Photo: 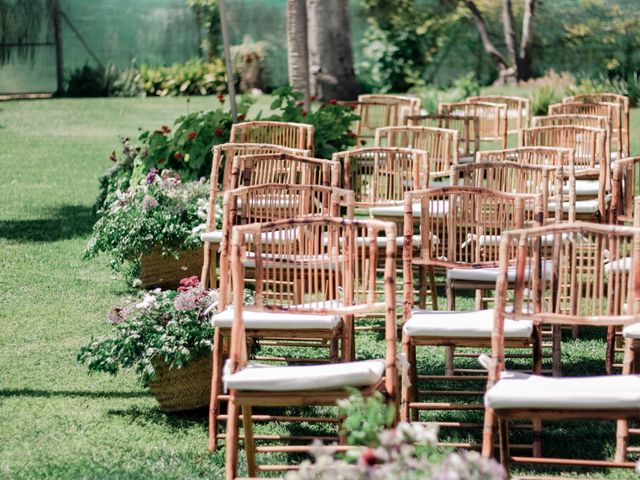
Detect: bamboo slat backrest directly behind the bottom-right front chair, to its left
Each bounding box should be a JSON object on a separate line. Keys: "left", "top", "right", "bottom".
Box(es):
{"left": 404, "top": 186, "right": 544, "bottom": 268}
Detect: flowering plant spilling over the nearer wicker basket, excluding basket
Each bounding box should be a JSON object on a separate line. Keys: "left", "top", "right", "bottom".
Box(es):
{"left": 77, "top": 277, "right": 218, "bottom": 384}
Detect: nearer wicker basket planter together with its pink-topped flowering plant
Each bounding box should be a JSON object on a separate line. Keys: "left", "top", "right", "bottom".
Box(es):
{"left": 78, "top": 276, "right": 218, "bottom": 412}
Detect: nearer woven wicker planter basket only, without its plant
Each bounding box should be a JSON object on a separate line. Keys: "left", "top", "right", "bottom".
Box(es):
{"left": 149, "top": 355, "right": 212, "bottom": 412}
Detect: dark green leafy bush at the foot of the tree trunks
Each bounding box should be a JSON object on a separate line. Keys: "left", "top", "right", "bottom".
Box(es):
{"left": 268, "top": 87, "right": 358, "bottom": 158}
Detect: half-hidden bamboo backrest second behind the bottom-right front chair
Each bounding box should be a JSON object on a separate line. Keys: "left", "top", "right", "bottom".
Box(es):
{"left": 451, "top": 161, "right": 564, "bottom": 223}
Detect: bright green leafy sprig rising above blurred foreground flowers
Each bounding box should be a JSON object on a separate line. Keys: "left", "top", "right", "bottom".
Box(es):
{"left": 338, "top": 389, "right": 395, "bottom": 447}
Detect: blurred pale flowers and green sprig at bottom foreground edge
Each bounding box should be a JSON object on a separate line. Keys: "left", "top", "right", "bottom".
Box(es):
{"left": 286, "top": 392, "right": 508, "bottom": 480}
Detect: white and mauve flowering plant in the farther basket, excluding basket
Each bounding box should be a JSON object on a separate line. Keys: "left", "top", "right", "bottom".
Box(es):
{"left": 85, "top": 169, "right": 222, "bottom": 282}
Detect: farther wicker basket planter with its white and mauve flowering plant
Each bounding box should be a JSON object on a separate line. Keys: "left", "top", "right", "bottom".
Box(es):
{"left": 85, "top": 169, "right": 222, "bottom": 288}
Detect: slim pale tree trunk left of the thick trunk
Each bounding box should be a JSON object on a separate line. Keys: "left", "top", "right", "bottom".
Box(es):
{"left": 287, "top": 0, "right": 311, "bottom": 111}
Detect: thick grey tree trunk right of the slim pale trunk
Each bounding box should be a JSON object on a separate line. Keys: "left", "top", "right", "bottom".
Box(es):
{"left": 307, "top": 0, "right": 359, "bottom": 100}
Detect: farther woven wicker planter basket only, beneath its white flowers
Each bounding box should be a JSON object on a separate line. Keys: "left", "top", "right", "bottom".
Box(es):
{"left": 140, "top": 248, "right": 204, "bottom": 289}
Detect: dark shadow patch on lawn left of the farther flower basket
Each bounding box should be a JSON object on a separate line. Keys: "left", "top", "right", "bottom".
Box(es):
{"left": 0, "top": 205, "right": 95, "bottom": 242}
